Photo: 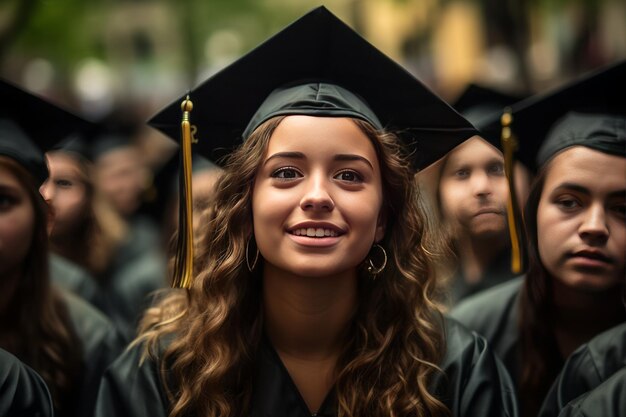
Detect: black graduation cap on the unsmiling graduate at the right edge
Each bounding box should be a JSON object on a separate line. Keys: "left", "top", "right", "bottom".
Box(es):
{"left": 502, "top": 61, "right": 626, "bottom": 169}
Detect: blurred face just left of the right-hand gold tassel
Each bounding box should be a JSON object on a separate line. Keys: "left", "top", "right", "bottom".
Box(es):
{"left": 439, "top": 136, "right": 509, "bottom": 238}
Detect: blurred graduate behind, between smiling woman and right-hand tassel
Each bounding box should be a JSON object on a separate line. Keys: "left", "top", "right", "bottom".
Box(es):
{"left": 418, "top": 84, "right": 520, "bottom": 305}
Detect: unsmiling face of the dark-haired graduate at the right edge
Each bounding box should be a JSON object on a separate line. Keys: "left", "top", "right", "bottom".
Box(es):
{"left": 537, "top": 147, "right": 626, "bottom": 291}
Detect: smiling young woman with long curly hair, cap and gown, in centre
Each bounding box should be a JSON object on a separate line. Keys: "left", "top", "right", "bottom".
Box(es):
{"left": 96, "top": 8, "right": 515, "bottom": 416}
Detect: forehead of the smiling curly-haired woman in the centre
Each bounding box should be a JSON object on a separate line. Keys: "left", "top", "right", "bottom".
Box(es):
{"left": 267, "top": 115, "right": 378, "bottom": 158}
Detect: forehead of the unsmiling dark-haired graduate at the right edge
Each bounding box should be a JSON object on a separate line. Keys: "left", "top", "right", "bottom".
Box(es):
{"left": 545, "top": 146, "right": 626, "bottom": 192}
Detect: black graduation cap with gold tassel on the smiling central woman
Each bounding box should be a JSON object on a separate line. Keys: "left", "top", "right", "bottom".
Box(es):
{"left": 149, "top": 7, "right": 477, "bottom": 285}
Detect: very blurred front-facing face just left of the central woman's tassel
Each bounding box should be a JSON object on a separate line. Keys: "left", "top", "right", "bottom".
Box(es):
{"left": 96, "top": 146, "right": 146, "bottom": 217}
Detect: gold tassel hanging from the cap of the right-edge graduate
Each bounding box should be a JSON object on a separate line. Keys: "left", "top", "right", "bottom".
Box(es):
{"left": 500, "top": 107, "right": 525, "bottom": 274}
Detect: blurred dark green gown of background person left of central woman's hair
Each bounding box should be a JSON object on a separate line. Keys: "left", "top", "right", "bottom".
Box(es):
{"left": 94, "top": 221, "right": 166, "bottom": 343}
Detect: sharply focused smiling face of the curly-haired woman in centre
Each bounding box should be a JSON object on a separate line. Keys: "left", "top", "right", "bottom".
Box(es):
{"left": 252, "top": 116, "right": 384, "bottom": 277}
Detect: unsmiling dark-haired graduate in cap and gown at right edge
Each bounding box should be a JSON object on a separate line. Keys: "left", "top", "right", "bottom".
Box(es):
{"left": 452, "top": 62, "right": 626, "bottom": 416}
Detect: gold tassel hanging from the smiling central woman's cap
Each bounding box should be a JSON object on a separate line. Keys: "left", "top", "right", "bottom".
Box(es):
{"left": 172, "top": 96, "right": 193, "bottom": 289}
